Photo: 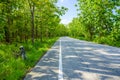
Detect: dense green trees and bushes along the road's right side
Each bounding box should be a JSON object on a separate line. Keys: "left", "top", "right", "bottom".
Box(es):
{"left": 67, "top": 0, "right": 120, "bottom": 47}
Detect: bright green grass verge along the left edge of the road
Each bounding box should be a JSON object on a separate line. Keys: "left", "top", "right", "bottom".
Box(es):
{"left": 0, "top": 38, "right": 57, "bottom": 80}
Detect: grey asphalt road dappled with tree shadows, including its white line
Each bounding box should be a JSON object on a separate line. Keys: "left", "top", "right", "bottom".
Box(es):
{"left": 24, "top": 37, "right": 120, "bottom": 80}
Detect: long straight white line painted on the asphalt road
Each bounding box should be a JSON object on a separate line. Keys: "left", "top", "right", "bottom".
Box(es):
{"left": 58, "top": 40, "right": 63, "bottom": 80}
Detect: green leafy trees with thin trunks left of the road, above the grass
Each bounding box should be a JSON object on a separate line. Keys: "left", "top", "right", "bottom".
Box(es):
{"left": 0, "top": 0, "right": 67, "bottom": 43}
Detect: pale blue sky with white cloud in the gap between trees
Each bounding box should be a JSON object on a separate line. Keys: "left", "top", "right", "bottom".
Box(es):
{"left": 57, "top": 0, "right": 77, "bottom": 24}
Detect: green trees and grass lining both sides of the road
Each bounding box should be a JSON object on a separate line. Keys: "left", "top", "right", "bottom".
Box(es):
{"left": 0, "top": 0, "right": 120, "bottom": 80}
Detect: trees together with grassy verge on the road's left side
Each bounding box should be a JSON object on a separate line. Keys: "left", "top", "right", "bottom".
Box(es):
{"left": 0, "top": 0, "right": 67, "bottom": 80}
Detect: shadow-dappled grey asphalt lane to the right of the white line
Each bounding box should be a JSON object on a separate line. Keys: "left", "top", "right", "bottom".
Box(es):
{"left": 62, "top": 40, "right": 120, "bottom": 80}
